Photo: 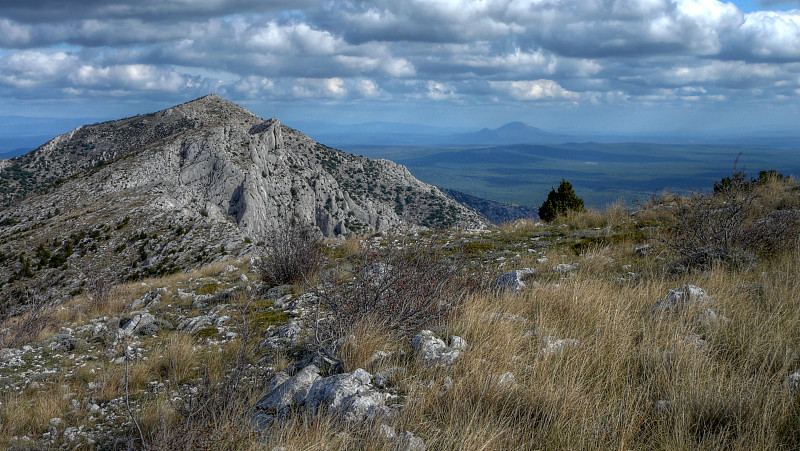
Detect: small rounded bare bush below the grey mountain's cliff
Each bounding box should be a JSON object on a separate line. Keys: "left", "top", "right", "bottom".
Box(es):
{"left": 259, "top": 221, "right": 324, "bottom": 286}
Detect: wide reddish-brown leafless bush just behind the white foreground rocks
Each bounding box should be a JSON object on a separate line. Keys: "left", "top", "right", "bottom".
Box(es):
{"left": 315, "top": 240, "right": 478, "bottom": 352}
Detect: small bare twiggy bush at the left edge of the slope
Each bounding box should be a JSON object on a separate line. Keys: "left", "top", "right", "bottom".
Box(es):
{"left": 0, "top": 285, "right": 55, "bottom": 348}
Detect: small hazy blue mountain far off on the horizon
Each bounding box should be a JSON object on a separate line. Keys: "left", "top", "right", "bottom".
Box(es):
{"left": 444, "top": 122, "right": 571, "bottom": 145}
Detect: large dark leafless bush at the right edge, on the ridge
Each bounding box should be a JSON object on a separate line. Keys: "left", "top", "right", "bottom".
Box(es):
{"left": 662, "top": 170, "right": 800, "bottom": 270}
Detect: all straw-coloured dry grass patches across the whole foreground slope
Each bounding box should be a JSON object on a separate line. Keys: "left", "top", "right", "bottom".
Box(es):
{"left": 0, "top": 189, "right": 800, "bottom": 450}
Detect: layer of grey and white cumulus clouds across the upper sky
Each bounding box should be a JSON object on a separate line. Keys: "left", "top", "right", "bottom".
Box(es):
{"left": 0, "top": 0, "right": 800, "bottom": 110}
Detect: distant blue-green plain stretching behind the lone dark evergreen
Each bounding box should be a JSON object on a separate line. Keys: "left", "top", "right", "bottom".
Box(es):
{"left": 342, "top": 142, "right": 800, "bottom": 208}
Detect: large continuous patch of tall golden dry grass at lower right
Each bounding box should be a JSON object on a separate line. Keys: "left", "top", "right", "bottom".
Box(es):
{"left": 265, "top": 224, "right": 800, "bottom": 450}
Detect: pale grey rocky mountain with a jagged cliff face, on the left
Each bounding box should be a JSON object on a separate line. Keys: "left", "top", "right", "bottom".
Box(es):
{"left": 0, "top": 95, "right": 484, "bottom": 314}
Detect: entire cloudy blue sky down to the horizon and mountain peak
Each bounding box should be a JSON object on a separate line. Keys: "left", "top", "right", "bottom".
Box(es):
{"left": 0, "top": 0, "right": 800, "bottom": 139}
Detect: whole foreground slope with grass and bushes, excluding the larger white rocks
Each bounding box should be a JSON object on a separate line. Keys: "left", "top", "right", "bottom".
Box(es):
{"left": 0, "top": 171, "right": 800, "bottom": 450}
